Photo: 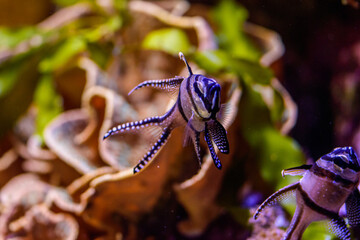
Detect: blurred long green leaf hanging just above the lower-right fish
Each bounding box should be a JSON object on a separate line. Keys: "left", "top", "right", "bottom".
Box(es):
{"left": 239, "top": 81, "right": 304, "bottom": 189}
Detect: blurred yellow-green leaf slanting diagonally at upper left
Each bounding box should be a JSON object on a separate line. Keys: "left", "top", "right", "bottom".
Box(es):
{"left": 39, "top": 36, "right": 86, "bottom": 72}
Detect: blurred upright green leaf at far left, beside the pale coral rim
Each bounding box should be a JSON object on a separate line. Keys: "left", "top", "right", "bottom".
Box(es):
{"left": 34, "top": 75, "right": 63, "bottom": 138}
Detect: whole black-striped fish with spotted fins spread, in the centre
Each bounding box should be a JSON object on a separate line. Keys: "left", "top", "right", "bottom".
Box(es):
{"left": 103, "top": 52, "right": 230, "bottom": 173}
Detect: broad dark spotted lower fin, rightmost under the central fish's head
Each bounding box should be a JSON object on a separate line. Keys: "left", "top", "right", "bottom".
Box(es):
{"left": 208, "top": 120, "right": 229, "bottom": 154}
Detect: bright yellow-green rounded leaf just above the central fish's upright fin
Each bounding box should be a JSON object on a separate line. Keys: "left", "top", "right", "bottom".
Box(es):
{"left": 142, "top": 28, "right": 191, "bottom": 54}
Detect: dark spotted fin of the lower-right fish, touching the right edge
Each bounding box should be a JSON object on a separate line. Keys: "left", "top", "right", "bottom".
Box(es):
{"left": 345, "top": 188, "right": 360, "bottom": 232}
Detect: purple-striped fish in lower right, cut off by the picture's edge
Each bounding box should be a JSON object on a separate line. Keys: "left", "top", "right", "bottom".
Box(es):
{"left": 254, "top": 147, "right": 360, "bottom": 240}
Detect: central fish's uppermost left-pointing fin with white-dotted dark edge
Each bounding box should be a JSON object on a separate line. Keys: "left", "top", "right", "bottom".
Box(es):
{"left": 128, "top": 77, "right": 184, "bottom": 95}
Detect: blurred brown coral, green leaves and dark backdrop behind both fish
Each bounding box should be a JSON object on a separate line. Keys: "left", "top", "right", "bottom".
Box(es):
{"left": 0, "top": 0, "right": 360, "bottom": 239}
